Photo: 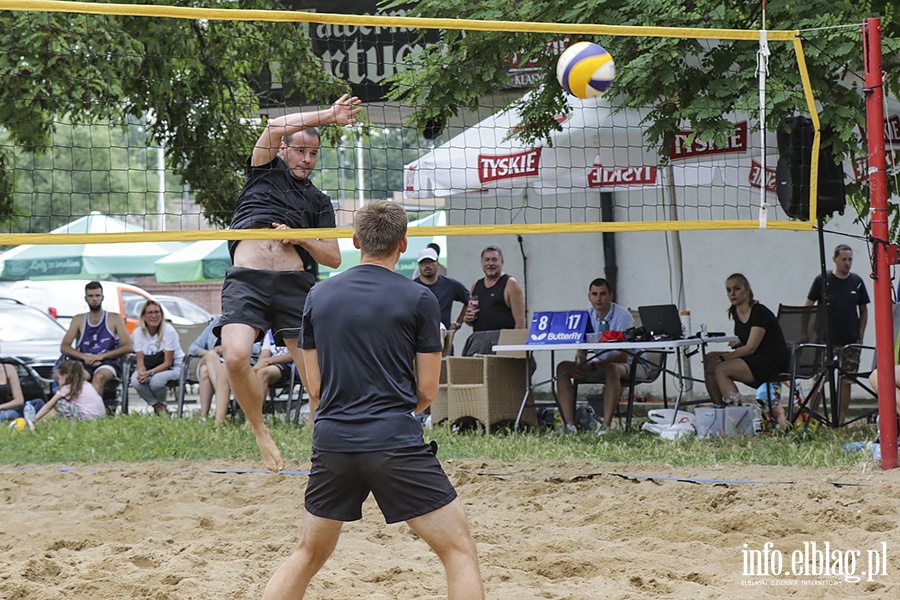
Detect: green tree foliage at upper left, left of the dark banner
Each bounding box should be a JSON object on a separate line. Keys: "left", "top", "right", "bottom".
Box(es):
{"left": 0, "top": 0, "right": 346, "bottom": 231}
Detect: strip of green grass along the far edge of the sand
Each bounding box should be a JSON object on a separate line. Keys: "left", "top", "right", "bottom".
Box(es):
{"left": 0, "top": 415, "right": 875, "bottom": 468}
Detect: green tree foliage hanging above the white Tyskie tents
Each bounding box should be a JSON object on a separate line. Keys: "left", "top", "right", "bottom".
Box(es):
{"left": 384, "top": 0, "right": 900, "bottom": 230}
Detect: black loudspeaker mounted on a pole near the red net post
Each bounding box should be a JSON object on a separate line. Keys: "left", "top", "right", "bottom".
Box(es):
{"left": 775, "top": 117, "right": 847, "bottom": 220}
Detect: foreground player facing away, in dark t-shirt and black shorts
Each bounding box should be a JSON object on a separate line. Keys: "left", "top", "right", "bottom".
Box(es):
{"left": 263, "top": 200, "right": 484, "bottom": 600}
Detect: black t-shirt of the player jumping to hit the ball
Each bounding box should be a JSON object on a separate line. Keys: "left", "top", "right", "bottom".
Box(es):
{"left": 228, "top": 156, "right": 335, "bottom": 276}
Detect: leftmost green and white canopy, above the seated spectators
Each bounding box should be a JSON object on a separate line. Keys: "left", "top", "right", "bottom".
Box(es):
{"left": 0, "top": 212, "right": 184, "bottom": 280}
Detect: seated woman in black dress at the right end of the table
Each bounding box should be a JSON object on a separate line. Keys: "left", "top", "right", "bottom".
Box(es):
{"left": 706, "top": 273, "right": 790, "bottom": 423}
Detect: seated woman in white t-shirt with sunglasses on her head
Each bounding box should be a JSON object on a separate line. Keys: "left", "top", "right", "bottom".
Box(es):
{"left": 131, "top": 300, "right": 184, "bottom": 415}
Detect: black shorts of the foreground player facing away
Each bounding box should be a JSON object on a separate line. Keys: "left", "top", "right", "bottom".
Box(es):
{"left": 305, "top": 444, "right": 456, "bottom": 523}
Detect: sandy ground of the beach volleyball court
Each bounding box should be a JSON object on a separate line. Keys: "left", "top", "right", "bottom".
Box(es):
{"left": 0, "top": 461, "right": 900, "bottom": 600}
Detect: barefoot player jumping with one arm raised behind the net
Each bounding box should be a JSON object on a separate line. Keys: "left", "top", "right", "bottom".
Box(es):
{"left": 221, "top": 94, "right": 361, "bottom": 471}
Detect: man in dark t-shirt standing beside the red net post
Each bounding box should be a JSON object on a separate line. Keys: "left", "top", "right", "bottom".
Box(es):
{"left": 805, "top": 244, "right": 869, "bottom": 424}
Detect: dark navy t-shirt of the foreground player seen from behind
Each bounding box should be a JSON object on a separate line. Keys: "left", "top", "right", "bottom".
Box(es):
{"left": 301, "top": 265, "right": 442, "bottom": 452}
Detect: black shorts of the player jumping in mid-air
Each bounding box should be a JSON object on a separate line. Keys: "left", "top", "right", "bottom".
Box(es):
{"left": 214, "top": 267, "right": 315, "bottom": 346}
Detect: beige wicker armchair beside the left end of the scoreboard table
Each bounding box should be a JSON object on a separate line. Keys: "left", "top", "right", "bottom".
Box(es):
{"left": 444, "top": 356, "right": 537, "bottom": 433}
